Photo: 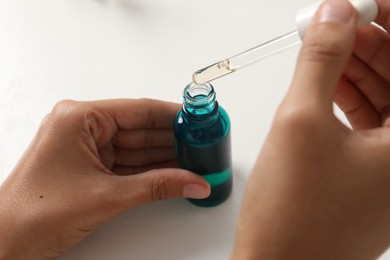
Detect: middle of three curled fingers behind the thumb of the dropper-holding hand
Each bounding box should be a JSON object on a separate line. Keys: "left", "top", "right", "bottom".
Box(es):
{"left": 344, "top": 56, "right": 390, "bottom": 114}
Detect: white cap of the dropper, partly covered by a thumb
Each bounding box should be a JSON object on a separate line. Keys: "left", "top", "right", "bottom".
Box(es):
{"left": 295, "top": 0, "right": 379, "bottom": 39}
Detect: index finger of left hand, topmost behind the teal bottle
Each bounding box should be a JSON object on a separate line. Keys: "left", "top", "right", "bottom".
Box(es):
{"left": 91, "top": 99, "right": 180, "bottom": 129}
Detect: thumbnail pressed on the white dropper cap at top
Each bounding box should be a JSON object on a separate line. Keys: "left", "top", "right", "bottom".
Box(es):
{"left": 318, "top": 0, "right": 354, "bottom": 23}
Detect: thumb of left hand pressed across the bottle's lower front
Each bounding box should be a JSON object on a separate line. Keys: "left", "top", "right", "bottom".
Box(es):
{"left": 109, "top": 168, "right": 210, "bottom": 208}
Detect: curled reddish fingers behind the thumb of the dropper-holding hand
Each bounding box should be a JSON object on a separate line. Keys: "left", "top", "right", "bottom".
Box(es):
{"left": 335, "top": 0, "right": 390, "bottom": 130}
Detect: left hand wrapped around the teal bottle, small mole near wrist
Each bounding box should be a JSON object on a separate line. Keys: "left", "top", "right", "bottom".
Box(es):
{"left": 0, "top": 99, "right": 210, "bottom": 259}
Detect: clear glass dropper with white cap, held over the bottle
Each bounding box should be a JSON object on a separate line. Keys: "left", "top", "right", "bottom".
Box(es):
{"left": 192, "top": 0, "right": 378, "bottom": 85}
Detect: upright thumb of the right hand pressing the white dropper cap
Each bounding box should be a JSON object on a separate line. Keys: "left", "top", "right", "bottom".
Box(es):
{"left": 287, "top": 0, "right": 356, "bottom": 111}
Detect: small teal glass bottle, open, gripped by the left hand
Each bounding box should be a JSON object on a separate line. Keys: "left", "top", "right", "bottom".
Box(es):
{"left": 174, "top": 83, "right": 233, "bottom": 207}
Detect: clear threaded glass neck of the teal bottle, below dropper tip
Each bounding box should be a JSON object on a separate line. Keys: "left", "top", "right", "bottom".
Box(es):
{"left": 183, "top": 83, "right": 218, "bottom": 119}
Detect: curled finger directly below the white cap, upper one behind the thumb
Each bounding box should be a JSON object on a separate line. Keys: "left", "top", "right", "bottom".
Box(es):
{"left": 354, "top": 25, "right": 390, "bottom": 82}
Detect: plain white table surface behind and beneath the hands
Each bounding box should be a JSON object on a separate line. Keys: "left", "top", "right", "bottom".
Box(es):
{"left": 0, "top": 0, "right": 390, "bottom": 260}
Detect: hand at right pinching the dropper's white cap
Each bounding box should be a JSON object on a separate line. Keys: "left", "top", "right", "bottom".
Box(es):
{"left": 232, "top": 0, "right": 390, "bottom": 260}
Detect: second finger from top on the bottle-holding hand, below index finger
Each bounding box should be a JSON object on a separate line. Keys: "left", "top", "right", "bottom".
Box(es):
{"left": 112, "top": 128, "right": 175, "bottom": 149}
